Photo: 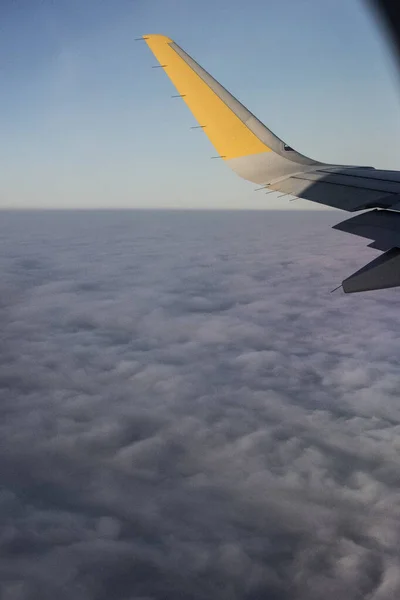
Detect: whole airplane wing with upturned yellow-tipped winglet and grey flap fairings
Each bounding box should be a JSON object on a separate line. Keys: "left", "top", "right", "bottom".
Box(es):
{"left": 141, "top": 35, "right": 400, "bottom": 293}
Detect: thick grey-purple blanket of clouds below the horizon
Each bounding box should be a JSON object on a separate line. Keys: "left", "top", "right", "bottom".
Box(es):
{"left": 0, "top": 207, "right": 400, "bottom": 600}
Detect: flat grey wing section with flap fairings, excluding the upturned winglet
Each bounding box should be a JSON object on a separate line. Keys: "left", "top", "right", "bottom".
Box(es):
{"left": 266, "top": 167, "right": 400, "bottom": 293}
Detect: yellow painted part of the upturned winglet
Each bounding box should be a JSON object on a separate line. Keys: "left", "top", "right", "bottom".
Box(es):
{"left": 143, "top": 35, "right": 270, "bottom": 160}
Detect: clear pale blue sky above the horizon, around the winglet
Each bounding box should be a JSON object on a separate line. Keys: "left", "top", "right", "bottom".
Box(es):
{"left": 0, "top": 0, "right": 400, "bottom": 208}
